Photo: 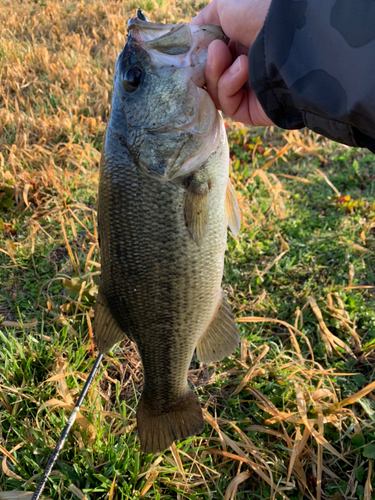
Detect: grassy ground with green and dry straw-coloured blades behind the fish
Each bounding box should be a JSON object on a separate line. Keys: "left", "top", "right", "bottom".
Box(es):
{"left": 0, "top": 0, "right": 375, "bottom": 500}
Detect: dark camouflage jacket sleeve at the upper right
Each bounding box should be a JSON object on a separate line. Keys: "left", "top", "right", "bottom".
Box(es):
{"left": 249, "top": 0, "right": 375, "bottom": 152}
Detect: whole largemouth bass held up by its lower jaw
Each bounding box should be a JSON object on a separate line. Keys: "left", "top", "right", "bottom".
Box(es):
{"left": 95, "top": 10, "right": 240, "bottom": 453}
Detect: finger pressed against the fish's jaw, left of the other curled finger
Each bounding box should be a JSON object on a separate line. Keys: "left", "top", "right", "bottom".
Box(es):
{"left": 206, "top": 40, "right": 232, "bottom": 109}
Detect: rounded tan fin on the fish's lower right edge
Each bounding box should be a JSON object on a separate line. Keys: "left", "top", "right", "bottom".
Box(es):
{"left": 197, "top": 290, "right": 240, "bottom": 363}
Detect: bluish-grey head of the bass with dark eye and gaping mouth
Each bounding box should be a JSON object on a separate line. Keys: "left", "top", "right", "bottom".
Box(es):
{"left": 111, "top": 9, "right": 226, "bottom": 181}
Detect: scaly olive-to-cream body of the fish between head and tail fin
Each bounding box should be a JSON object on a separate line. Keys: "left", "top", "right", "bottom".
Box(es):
{"left": 99, "top": 135, "right": 228, "bottom": 396}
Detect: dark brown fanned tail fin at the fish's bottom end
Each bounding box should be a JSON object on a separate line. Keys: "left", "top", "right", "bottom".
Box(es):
{"left": 137, "top": 389, "right": 204, "bottom": 453}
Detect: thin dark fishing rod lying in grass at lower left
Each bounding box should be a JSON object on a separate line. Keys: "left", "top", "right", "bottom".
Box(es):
{"left": 31, "top": 353, "right": 104, "bottom": 500}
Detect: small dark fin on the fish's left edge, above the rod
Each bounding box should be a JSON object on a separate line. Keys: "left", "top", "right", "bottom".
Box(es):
{"left": 94, "top": 289, "right": 126, "bottom": 353}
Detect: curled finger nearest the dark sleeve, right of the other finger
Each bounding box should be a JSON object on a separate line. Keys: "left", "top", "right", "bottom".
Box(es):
{"left": 217, "top": 55, "right": 251, "bottom": 124}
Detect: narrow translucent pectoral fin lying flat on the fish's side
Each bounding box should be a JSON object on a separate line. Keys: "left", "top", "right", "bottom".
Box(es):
{"left": 184, "top": 179, "right": 209, "bottom": 247}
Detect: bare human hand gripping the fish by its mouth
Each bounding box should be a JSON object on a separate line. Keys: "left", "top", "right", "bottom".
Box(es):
{"left": 190, "top": 0, "right": 273, "bottom": 126}
